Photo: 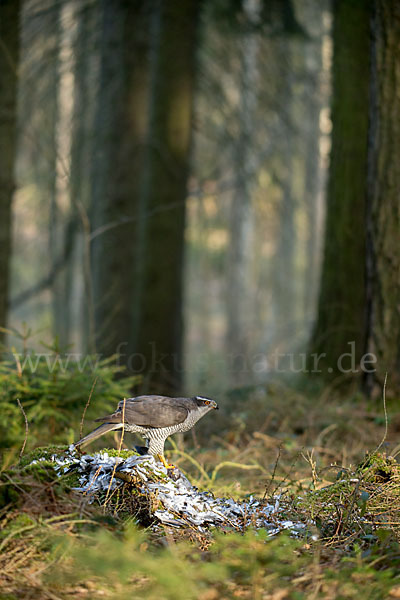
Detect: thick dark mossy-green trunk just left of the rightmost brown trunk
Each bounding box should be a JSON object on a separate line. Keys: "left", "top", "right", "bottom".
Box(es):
{"left": 309, "top": 0, "right": 370, "bottom": 377}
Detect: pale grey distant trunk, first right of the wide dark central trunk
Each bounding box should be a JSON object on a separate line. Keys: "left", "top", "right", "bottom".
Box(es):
{"left": 227, "top": 0, "right": 260, "bottom": 385}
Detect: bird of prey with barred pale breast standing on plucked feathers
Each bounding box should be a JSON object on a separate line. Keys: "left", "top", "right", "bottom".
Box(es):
{"left": 75, "top": 396, "right": 218, "bottom": 469}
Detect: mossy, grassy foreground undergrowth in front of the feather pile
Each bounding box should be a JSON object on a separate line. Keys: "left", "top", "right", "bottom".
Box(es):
{"left": 0, "top": 438, "right": 400, "bottom": 600}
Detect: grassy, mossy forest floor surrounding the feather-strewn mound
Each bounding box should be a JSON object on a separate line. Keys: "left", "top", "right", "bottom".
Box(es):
{"left": 0, "top": 384, "right": 400, "bottom": 600}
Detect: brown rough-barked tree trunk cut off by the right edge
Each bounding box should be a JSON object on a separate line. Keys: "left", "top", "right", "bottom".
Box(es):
{"left": 365, "top": 0, "right": 400, "bottom": 396}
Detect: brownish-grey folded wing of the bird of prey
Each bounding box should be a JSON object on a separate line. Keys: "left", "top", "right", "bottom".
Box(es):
{"left": 96, "top": 396, "right": 189, "bottom": 428}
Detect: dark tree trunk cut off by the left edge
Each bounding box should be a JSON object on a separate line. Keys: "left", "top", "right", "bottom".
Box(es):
{"left": 0, "top": 0, "right": 20, "bottom": 341}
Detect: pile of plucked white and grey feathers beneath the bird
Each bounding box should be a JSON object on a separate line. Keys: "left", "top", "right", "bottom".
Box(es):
{"left": 33, "top": 446, "right": 306, "bottom": 536}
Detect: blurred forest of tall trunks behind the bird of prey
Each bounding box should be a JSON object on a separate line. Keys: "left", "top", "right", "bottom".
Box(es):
{"left": 0, "top": 0, "right": 400, "bottom": 597}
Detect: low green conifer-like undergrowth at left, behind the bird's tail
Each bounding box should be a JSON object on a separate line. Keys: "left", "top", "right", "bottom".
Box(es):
{"left": 0, "top": 330, "right": 139, "bottom": 454}
